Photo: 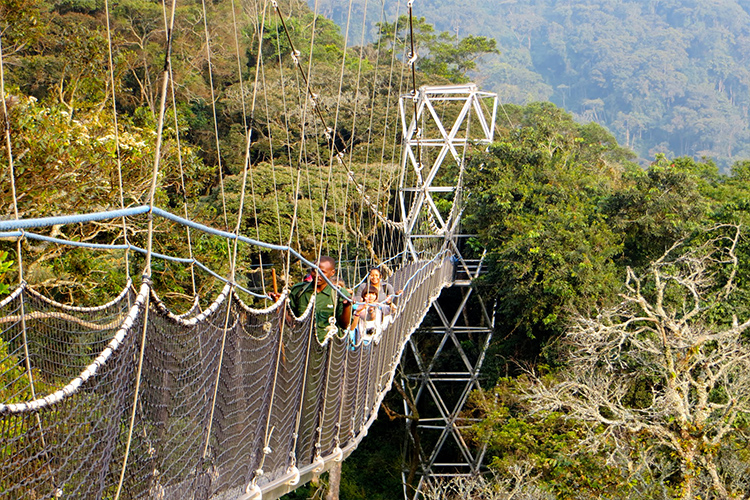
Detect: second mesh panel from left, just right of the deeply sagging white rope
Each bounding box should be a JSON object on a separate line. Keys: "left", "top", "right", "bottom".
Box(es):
{"left": 124, "top": 292, "right": 226, "bottom": 498}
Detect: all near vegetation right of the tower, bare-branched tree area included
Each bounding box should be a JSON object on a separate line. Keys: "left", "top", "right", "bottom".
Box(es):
{"left": 464, "top": 104, "right": 750, "bottom": 498}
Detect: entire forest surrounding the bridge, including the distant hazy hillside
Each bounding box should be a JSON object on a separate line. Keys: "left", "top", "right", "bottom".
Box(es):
{"left": 0, "top": 0, "right": 750, "bottom": 498}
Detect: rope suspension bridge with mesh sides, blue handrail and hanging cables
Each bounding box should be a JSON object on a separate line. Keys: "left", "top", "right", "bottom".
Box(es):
{"left": 0, "top": 1, "right": 497, "bottom": 500}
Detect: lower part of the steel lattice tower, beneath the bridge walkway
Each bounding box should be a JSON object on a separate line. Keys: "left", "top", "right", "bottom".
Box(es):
{"left": 400, "top": 260, "right": 493, "bottom": 499}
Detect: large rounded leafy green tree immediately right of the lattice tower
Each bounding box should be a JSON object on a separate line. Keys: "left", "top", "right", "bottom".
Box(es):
{"left": 464, "top": 104, "right": 627, "bottom": 350}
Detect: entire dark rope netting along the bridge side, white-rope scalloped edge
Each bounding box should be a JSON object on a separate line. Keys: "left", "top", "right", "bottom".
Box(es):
{"left": 0, "top": 254, "right": 452, "bottom": 499}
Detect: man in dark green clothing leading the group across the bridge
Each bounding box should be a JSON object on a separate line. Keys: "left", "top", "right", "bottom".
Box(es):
{"left": 269, "top": 255, "right": 352, "bottom": 342}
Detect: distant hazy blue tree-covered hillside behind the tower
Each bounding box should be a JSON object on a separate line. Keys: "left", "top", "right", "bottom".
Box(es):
{"left": 310, "top": 0, "right": 750, "bottom": 172}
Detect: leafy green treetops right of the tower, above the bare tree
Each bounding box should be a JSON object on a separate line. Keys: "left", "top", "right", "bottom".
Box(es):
{"left": 464, "top": 104, "right": 748, "bottom": 358}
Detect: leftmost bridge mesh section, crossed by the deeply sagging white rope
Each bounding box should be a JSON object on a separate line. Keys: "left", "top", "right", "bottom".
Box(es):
{"left": 0, "top": 284, "right": 140, "bottom": 499}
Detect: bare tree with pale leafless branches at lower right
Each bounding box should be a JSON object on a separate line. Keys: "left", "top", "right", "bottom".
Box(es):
{"left": 527, "top": 226, "right": 750, "bottom": 499}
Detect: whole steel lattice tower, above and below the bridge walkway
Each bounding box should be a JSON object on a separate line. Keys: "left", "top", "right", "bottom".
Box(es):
{"left": 399, "top": 84, "right": 497, "bottom": 499}
